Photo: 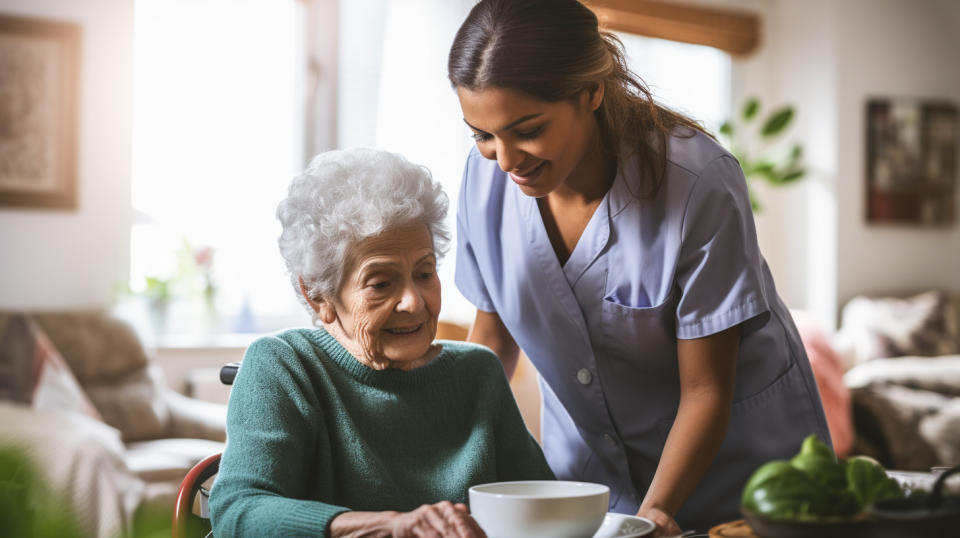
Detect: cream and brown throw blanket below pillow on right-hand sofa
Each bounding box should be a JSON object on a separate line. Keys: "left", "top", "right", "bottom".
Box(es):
{"left": 844, "top": 355, "right": 960, "bottom": 471}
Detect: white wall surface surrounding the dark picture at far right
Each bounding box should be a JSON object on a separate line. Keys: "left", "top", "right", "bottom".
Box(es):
{"left": 836, "top": 0, "right": 960, "bottom": 304}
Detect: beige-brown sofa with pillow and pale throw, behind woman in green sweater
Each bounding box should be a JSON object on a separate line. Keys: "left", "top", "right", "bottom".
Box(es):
{"left": 0, "top": 310, "right": 226, "bottom": 536}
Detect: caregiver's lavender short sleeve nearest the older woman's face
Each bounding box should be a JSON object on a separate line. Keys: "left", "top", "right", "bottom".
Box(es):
{"left": 454, "top": 152, "right": 496, "bottom": 312}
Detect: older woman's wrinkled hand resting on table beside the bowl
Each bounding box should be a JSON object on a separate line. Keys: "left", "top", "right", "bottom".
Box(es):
{"left": 330, "top": 501, "right": 487, "bottom": 538}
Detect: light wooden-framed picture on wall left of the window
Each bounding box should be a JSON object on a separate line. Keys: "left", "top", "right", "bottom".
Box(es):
{"left": 0, "top": 15, "right": 80, "bottom": 209}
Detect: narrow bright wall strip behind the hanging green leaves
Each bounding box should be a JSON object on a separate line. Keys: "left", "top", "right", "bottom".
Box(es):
{"left": 770, "top": 0, "right": 838, "bottom": 326}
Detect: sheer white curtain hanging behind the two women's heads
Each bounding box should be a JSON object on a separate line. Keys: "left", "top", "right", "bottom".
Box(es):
{"left": 338, "top": 0, "right": 475, "bottom": 324}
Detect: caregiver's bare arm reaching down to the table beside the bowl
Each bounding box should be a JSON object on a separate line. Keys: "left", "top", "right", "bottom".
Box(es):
{"left": 639, "top": 325, "right": 740, "bottom": 531}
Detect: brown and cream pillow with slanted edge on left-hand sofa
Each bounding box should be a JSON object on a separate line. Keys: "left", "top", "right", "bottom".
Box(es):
{"left": 0, "top": 314, "right": 103, "bottom": 420}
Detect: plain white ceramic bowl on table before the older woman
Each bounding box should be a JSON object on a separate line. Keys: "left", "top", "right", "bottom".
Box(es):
{"left": 469, "top": 480, "right": 610, "bottom": 538}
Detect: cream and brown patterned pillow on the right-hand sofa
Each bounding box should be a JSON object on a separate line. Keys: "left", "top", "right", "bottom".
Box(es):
{"left": 841, "top": 291, "right": 960, "bottom": 366}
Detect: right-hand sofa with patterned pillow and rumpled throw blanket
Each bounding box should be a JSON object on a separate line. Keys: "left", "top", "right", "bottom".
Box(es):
{"left": 834, "top": 291, "right": 960, "bottom": 471}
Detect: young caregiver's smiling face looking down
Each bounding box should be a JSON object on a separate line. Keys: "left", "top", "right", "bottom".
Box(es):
{"left": 457, "top": 87, "right": 603, "bottom": 198}
